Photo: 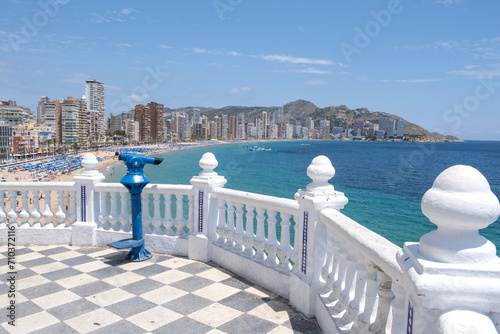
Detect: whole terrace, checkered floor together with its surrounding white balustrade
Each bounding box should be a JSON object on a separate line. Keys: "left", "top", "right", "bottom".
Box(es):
{"left": 0, "top": 153, "right": 500, "bottom": 334}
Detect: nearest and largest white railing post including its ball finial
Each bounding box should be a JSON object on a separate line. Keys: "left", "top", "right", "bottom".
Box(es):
{"left": 397, "top": 165, "right": 500, "bottom": 334}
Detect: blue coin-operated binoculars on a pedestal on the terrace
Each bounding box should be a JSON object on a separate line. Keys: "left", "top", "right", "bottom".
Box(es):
{"left": 108, "top": 152, "right": 163, "bottom": 262}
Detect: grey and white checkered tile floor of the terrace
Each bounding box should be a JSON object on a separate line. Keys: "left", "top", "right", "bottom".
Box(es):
{"left": 0, "top": 246, "right": 321, "bottom": 334}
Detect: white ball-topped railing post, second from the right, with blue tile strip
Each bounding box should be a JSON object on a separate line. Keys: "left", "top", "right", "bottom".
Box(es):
{"left": 290, "top": 155, "right": 348, "bottom": 317}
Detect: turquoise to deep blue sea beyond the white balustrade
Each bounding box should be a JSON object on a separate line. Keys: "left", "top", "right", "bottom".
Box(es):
{"left": 104, "top": 140, "right": 500, "bottom": 255}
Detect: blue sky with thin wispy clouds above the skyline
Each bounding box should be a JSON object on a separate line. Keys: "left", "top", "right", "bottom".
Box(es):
{"left": 0, "top": 0, "right": 500, "bottom": 140}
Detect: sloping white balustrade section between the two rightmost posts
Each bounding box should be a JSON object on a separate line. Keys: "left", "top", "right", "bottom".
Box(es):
{"left": 319, "top": 209, "right": 404, "bottom": 333}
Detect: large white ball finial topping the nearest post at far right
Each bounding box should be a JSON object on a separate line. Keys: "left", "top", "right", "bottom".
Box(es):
{"left": 419, "top": 165, "right": 500, "bottom": 263}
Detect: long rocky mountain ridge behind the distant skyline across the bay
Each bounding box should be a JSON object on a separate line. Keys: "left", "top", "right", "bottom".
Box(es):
{"left": 165, "top": 100, "right": 462, "bottom": 142}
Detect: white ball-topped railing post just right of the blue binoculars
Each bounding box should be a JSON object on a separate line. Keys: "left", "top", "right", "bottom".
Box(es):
{"left": 188, "top": 152, "right": 227, "bottom": 262}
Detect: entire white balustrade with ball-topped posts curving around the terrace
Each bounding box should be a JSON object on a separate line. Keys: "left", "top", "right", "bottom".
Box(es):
{"left": 0, "top": 153, "right": 500, "bottom": 334}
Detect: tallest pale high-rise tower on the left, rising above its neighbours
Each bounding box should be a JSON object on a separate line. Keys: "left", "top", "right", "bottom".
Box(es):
{"left": 85, "top": 79, "right": 105, "bottom": 140}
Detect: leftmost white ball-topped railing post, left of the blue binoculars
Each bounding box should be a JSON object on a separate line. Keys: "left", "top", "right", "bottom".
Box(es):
{"left": 71, "top": 153, "right": 105, "bottom": 246}
